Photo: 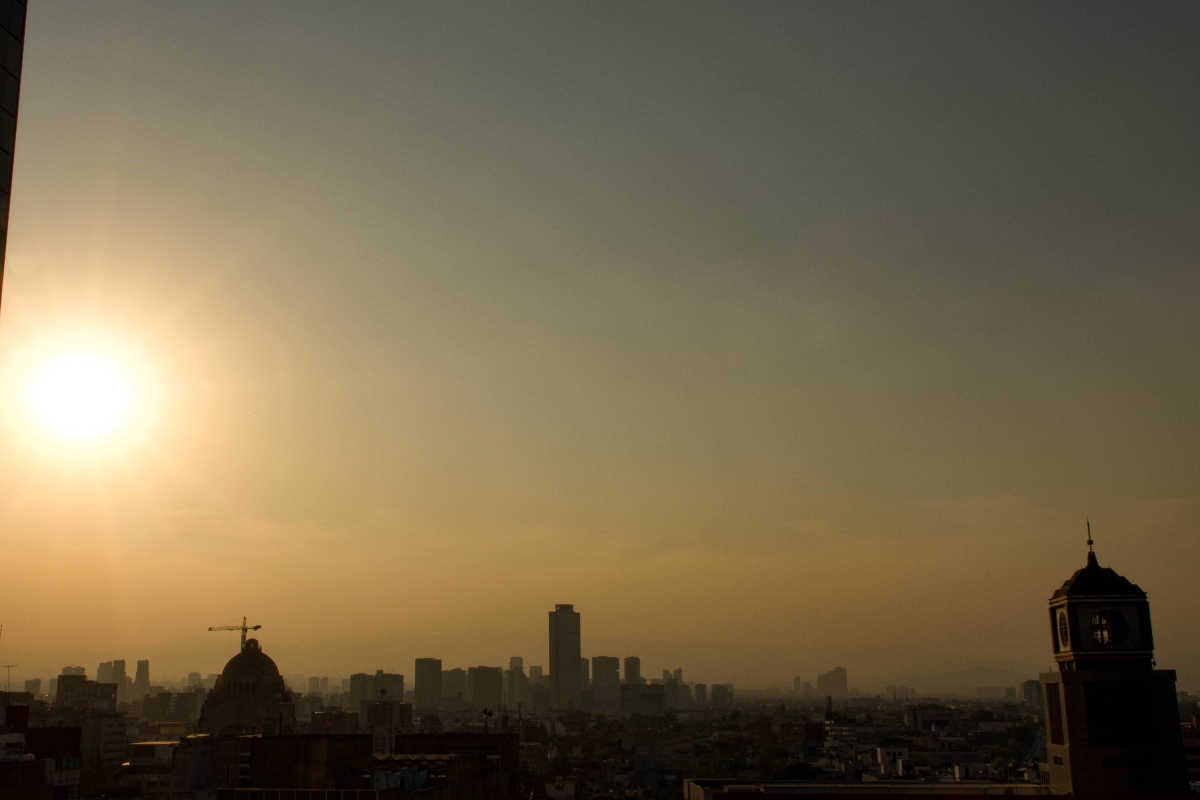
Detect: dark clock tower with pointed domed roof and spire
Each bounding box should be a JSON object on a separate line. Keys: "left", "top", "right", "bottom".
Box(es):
{"left": 1042, "top": 535, "right": 1188, "bottom": 794}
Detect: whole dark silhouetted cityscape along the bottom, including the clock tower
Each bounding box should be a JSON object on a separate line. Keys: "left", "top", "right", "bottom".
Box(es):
{"left": 0, "top": 553, "right": 1200, "bottom": 800}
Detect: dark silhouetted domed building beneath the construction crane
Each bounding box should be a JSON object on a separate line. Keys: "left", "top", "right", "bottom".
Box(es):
{"left": 198, "top": 639, "right": 296, "bottom": 734}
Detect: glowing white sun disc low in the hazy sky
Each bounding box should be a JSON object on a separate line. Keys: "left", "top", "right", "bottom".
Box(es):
{"left": 29, "top": 353, "right": 133, "bottom": 440}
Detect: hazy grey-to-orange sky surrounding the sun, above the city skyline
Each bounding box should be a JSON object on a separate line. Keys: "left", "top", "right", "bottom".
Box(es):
{"left": 0, "top": 0, "right": 1200, "bottom": 688}
